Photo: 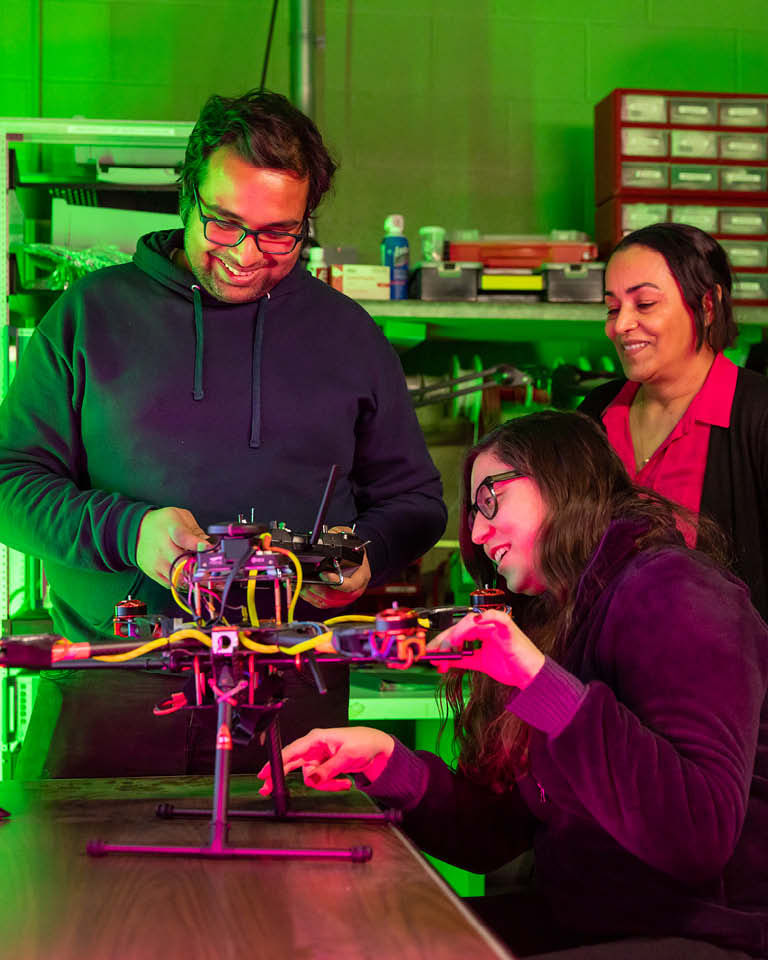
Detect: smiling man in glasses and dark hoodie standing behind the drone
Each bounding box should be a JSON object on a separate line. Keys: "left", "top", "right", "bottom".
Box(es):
{"left": 0, "top": 92, "right": 445, "bottom": 777}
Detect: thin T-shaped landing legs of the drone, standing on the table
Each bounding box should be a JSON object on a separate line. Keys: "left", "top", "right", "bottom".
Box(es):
{"left": 86, "top": 667, "right": 388, "bottom": 863}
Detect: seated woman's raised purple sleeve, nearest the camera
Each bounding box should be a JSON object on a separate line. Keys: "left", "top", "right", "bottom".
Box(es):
{"left": 507, "top": 551, "right": 768, "bottom": 883}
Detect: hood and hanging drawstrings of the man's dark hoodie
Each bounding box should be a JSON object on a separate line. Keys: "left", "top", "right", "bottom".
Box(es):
{"left": 133, "top": 230, "right": 308, "bottom": 448}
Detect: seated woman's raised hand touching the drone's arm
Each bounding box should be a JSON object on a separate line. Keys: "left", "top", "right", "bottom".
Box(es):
{"left": 427, "top": 610, "right": 544, "bottom": 690}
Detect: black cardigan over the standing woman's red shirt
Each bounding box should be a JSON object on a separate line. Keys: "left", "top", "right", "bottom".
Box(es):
{"left": 579, "top": 369, "right": 768, "bottom": 620}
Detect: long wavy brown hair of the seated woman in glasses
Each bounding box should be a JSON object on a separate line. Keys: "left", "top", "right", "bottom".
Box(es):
{"left": 444, "top": 410, "right": 726, "bottom": 788}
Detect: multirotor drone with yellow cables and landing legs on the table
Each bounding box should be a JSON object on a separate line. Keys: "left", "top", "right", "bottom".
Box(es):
{"left": 0, "top": 468, "right": 509, "bottom": 862}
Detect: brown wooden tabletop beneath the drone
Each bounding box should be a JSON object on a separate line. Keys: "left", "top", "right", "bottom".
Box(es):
{"left": 0, "top": 777, "right": 511, "bottom": 960}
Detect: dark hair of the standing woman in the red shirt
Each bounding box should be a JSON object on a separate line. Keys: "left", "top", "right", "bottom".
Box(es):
{"left": 611, "top": 223, "right": 738, "bottom": 353}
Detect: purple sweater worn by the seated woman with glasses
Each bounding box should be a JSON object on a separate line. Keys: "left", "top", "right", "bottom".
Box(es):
{"left": 364, "top": 521, "right": 768, "bottom": 955}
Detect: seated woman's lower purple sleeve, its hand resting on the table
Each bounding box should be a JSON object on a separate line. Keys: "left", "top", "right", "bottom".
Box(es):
{"left": 355, "top": 741, "right": 535, "bottom": 873}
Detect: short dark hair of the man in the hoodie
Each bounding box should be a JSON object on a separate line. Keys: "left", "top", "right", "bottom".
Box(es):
{"left": 179, "top": 90, "right": 336, "bottom": 223}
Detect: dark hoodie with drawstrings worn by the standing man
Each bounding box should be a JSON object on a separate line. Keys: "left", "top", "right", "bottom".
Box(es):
{"left": 0, "top": 231, "right": 446, "bottom": 640}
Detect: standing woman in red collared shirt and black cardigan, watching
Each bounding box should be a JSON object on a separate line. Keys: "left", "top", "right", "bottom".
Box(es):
{"left": 581, "top": 223, "right": 768, "bottom": 618}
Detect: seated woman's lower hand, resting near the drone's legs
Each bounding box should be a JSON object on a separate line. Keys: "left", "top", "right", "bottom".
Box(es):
{"left": 256, "top": 727, "right": 395, "bottom": 796}
